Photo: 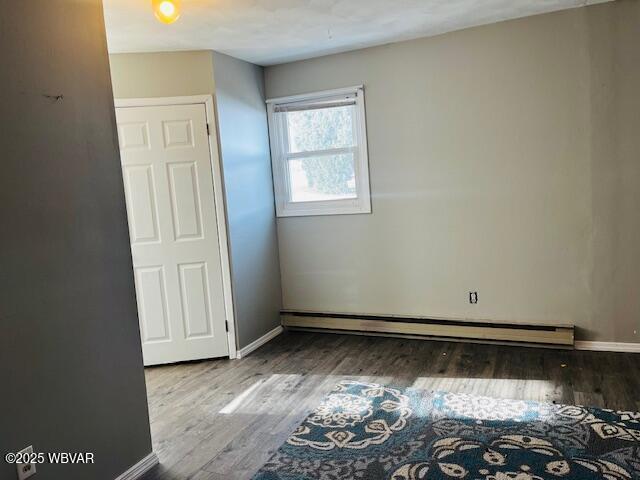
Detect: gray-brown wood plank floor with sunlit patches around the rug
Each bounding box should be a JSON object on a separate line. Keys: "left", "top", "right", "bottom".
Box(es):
{"left": 144, "top": 332, "right": 640, "bottom": 480}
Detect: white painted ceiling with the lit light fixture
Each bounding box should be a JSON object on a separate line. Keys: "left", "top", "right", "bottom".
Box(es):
{"left": 104, "top": 0, "right": 607, "bottom": 65}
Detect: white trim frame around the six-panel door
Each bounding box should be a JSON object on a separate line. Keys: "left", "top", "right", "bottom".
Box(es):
{"left": 114, "top": 95, "right": 237, "bottom": 359}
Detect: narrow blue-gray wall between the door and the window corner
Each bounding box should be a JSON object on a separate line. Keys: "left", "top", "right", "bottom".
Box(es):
{"left": 213, "top": 53, "right": 282, "bottom": 348}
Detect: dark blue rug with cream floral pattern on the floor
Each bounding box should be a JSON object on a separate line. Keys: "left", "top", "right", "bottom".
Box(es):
{"left": 254, "top": 381, "right": 640, "bottom": 480}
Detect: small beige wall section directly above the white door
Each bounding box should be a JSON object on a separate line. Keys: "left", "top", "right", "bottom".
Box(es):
{"left": 109, "top": 50, "right": 215, "bottom": 98}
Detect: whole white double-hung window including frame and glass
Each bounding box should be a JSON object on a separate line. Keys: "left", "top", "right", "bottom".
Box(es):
{"left": 267, "top": 87, "right": 371, "bottom": 217}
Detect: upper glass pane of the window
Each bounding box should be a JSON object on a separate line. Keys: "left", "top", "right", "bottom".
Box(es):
{"left": 286, "top": 105, "right": 354, "bottom": 153}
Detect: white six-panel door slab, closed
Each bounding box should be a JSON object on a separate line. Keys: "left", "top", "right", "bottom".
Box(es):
{"left": 116, "top": 104, "right": 229, "bottom": 365}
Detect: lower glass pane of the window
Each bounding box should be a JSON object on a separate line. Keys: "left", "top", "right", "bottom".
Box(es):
{"left": 289, "top": 153, "right": 356, "bottom": 202}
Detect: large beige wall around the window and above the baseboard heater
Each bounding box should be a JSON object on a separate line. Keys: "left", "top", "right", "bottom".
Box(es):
{"left": 265, "top": 0, "right": 640, "bottom": 341}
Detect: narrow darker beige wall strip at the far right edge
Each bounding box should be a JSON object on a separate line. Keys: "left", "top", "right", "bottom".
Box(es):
{"left": 586, "top": 0, "right": 640, "bottom": 342}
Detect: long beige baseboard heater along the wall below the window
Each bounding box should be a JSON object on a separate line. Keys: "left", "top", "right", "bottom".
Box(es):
{"left": 281, "top": 310, "right": 574, "bottom": 348}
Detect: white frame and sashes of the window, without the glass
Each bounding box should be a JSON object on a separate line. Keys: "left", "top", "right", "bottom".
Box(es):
{"left": 267, "top": 85, "right": 371, "bottom": 217}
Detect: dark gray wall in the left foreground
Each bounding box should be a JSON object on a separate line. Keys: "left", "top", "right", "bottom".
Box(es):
{"left": 0, "top": 0, "right": 151, "bottom": 480}
